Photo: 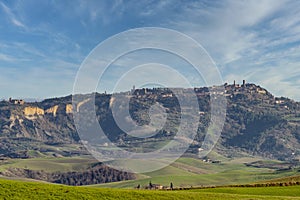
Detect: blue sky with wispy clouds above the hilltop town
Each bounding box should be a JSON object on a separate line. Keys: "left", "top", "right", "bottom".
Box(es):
{"left": 0, "top": 0, "right": 300, "bottom": 101}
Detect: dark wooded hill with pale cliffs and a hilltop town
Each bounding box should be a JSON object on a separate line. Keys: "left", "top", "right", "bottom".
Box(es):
{"left": 0, "top": 84, "right": 300, "bottom": 160}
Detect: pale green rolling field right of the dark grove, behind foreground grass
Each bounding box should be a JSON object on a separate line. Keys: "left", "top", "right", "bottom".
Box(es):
{"left": 89, "top": 158, "right": 300, "bottom": 188}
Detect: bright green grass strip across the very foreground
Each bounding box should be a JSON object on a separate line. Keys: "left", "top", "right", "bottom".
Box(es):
{"left": 0, "top": 180, "right": 300, "bottom": 200}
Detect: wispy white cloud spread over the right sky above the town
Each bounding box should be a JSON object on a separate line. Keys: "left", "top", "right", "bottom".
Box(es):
{"left": 152, "top": 0, "right": 300, "bottom": 100}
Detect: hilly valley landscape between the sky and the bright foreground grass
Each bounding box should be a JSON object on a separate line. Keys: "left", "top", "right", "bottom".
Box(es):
{"left": 0, "top": 83, "right": 300, "bottom": 189}
